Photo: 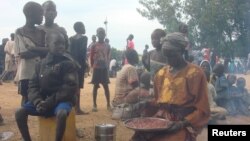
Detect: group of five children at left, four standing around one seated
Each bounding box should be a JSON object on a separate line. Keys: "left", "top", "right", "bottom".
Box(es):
{"left": 10, "top": 1, "right": 111, "bottom": 141}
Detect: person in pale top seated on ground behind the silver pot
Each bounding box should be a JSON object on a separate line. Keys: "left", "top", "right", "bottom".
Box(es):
{"left": 112, "top": 50, "right": 150, "bottom": 119}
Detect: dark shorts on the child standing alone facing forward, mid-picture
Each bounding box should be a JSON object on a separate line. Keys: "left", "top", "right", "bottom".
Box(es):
{"left": 91, "top": 68, "right": 110, "bottom": 84}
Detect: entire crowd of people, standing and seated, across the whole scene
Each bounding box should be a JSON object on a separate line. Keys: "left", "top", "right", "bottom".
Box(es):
{"left": 0, "top": 1, "right": 250, "bottom": 141}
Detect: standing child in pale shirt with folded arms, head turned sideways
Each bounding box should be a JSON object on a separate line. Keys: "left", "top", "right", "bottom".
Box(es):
{"left": 15, "top": 2, "right": 48, "bottom": 104}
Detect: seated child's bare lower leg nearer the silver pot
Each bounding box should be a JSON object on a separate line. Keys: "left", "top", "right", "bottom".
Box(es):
{"left": 56, "top": 110, "right": 67, "bottom": 141}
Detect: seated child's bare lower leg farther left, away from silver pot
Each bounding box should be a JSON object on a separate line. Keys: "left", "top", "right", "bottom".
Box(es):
{"left": 15, "top": 108, "right": 31, "bottom": 141}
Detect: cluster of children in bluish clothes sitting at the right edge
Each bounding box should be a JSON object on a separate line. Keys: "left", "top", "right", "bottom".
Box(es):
{"left": 212, "top": 64, "right": 250, "bottom": 116}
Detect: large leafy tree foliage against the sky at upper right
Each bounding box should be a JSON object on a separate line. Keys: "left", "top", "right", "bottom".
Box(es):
{"left": 137, "top": 0, "right": 250, "bottom": 56}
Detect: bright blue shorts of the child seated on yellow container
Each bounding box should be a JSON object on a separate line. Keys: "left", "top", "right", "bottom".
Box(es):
{"left": 22, "top": 101, "right": 72, "bottom": 117}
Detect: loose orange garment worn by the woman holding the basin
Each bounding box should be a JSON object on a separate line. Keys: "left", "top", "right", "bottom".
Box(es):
{"left": 131, "top": 63, "right": 210, "bottom": 141}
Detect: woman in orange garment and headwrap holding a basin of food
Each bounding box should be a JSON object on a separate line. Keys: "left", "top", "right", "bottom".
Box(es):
{"left": 132, "top": 32, "right": 210, "bottom": 141}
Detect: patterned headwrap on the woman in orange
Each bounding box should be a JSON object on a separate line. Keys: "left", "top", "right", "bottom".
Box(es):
{"left": 161, "top": 32, "right": 188, "bottom": 49}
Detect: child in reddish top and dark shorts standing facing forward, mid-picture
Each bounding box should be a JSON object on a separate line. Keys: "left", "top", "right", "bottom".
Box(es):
{"left": 90, "top": 27, "right": 111, "bottom": 112}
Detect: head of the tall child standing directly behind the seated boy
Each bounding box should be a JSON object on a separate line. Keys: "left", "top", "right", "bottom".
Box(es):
{"left": 42, "top": 0, "right": 57, "bottom": 23}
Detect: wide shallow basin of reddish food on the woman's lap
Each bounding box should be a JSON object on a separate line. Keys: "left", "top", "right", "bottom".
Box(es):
{"left": 124, "top": 117, "right": 171, "bottom": 131}
